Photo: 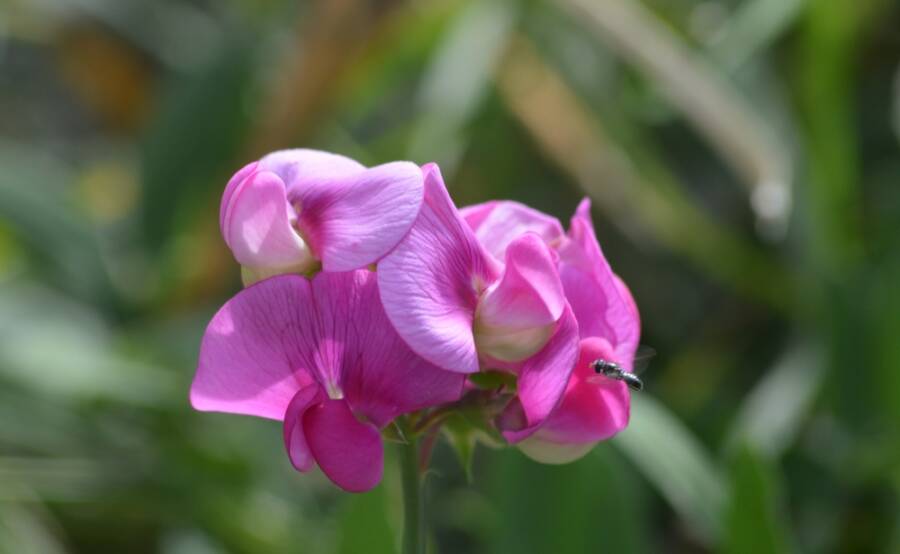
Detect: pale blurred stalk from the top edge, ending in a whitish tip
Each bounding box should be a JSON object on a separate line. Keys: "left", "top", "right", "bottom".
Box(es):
{"left": 557, "top": 0, "right": 792, "bottom": 235}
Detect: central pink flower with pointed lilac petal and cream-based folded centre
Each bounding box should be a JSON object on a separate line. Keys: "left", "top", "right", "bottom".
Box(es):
{"left": 378, "top": 164, "right": 578, "bottom": 442}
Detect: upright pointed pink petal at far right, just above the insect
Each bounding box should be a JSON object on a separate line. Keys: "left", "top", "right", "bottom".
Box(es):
{"left": 559, "top": 199, "right": 641, "bottom": 362}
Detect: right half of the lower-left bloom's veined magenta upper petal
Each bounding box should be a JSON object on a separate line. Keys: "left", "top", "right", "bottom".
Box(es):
{"left": 312, "top": 270, "right": 465, "bottom": 427}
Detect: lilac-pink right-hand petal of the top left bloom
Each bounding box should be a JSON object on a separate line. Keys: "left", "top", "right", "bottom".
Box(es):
{"left": 290, "top": 162, "right": 424, "bottom": 271}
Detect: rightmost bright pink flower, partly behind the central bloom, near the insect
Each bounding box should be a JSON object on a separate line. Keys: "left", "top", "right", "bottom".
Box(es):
{"left": 461, "top": 199, "right": 640, "bottom": 463}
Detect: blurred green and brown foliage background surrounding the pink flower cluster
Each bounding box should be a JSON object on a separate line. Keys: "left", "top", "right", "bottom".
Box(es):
{"left": 0, "top": 0, "right": 900, "bottom": 554}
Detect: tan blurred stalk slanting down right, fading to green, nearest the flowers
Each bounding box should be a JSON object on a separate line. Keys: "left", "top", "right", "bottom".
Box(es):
{"left": 497, "top": 37, "right": 795, "bottom": 313}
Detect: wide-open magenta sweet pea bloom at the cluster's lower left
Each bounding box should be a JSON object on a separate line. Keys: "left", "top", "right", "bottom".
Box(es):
{"left": 191, "top": 270, "right": 465, "bottom": 492}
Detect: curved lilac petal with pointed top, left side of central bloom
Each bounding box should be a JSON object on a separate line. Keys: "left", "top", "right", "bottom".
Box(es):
{"left": 378, "top": 164, "right": 497, "bottom": 373}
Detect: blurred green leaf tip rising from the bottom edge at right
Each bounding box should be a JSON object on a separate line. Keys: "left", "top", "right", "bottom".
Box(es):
{"left": 723, "top": 446, "right": 790, "bottom": 554}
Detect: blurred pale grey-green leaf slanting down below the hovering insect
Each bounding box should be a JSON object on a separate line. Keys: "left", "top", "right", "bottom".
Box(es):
{"left": 612, "top": 396, "right": 726, "bottom": 544}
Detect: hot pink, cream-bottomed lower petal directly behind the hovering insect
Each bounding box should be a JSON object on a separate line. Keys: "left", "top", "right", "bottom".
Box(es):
{"left": 525, "top": 338, "right": 630, "bottom": 463}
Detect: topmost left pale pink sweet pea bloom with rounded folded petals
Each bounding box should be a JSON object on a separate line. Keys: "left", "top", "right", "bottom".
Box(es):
{"left": 219, "top": 149, "right": 423, "bottom": 284}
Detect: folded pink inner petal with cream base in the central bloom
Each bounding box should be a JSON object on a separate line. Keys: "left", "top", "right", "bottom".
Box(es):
{"left": 475, "top": 233, "right": 566, "bottom": 362}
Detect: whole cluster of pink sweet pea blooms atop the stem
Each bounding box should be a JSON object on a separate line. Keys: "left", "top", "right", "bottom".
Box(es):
{"left": 191, "top": 150, "right": 640, "bottom": 491}
